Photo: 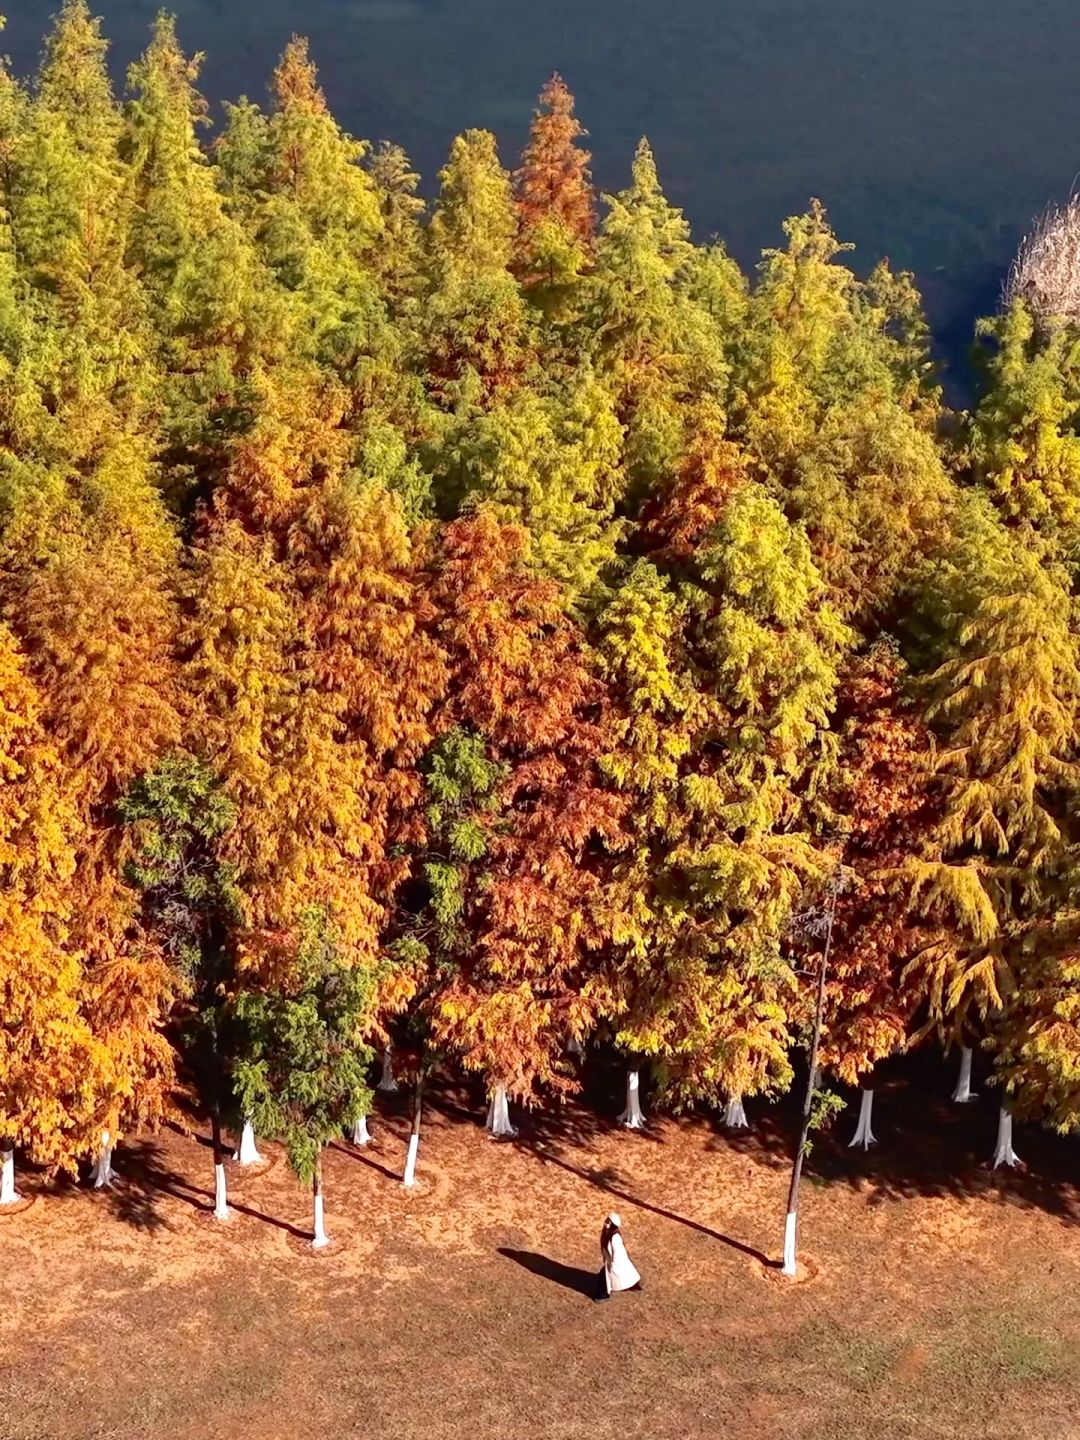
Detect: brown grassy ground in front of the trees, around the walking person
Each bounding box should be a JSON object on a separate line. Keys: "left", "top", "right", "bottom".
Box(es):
{"left": 0, "top": 1066, "right": 1080, "bottom": 1440}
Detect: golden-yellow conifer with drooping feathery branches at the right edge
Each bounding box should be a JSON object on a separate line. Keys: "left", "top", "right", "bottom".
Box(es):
{"left": 907, "top": 495, "right": 1077, "bottom": 1071}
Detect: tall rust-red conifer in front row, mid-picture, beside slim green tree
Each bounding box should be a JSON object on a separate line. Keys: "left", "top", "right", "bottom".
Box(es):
{"left": 409, "top": 511, "right": 622, "bottom": 1099}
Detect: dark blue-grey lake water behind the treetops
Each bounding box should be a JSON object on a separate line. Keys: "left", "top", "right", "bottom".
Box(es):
{"left": 0, "top": 0, "right": 1080, "bottom": 385}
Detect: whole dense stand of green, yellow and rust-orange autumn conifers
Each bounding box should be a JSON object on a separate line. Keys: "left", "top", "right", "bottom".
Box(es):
{"left": 0, "top": 0, "right": 1080, "bottom": 1267}
